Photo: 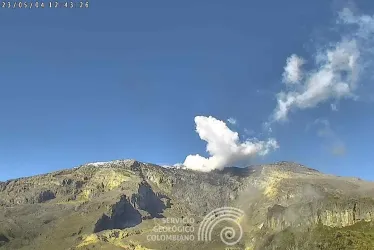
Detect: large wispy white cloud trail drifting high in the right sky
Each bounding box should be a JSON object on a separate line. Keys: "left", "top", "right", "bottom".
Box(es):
{"left": 273, "top": 9, "right": 374, "bottom": 121}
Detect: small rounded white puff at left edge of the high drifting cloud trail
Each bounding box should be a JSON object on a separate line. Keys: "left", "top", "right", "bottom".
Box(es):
{"left": 283, "top": 54, "right": 305, "bottom": 84}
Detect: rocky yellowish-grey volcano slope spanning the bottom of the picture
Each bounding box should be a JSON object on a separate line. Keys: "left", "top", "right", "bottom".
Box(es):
{"left": 0, "top": 160, "right": 374, "bottom": 249}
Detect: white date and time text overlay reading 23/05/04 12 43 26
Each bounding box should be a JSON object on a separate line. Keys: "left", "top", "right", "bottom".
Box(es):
{"left": 0, "top": 0, "right": 90, "bottom": 9}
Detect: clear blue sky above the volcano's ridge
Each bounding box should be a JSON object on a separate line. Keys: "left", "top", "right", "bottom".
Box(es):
{"left": 0, "top": 0, "right": 374, "bottom": 180}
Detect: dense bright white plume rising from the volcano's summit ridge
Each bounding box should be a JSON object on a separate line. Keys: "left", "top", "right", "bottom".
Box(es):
{"left": 183, "top": 116, "right": 278, "bottom": 172}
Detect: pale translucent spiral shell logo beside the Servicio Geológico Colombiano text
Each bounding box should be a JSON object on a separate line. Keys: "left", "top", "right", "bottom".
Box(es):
{"left": 197, "top": 207, "right": 244, "bottom": 246}
